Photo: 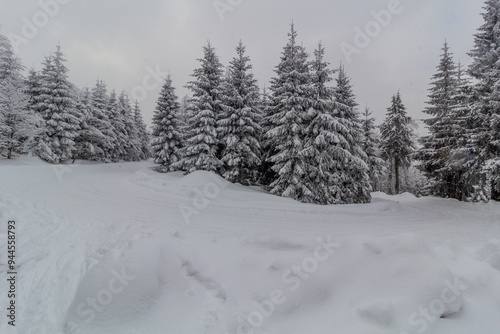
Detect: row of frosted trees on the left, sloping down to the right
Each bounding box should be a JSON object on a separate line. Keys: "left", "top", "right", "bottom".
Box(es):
{"left": 0, "top": 35, "right": 150, "bottom": 164}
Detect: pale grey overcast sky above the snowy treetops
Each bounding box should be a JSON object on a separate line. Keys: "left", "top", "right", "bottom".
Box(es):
{"left": 0, "top": 0, "right": 484, "bottom": 129}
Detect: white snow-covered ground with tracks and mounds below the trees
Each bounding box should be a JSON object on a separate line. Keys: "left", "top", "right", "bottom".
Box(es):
{"left": 0, "top": 158, "right": 500, "bottom": 334}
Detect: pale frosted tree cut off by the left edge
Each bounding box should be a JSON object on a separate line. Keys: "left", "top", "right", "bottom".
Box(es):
{"left": 0, "top": 35, "right": 37, "bottom": 159}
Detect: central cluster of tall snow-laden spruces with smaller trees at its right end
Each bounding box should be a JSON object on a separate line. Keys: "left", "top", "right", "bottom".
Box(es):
{"left": 148, "top": 25, "right": 406, "bottom": 204}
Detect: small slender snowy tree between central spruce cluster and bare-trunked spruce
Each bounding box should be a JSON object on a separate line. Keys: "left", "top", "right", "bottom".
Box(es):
{"left": 362, "top": 107, "right": 387, "bottom": 191}
